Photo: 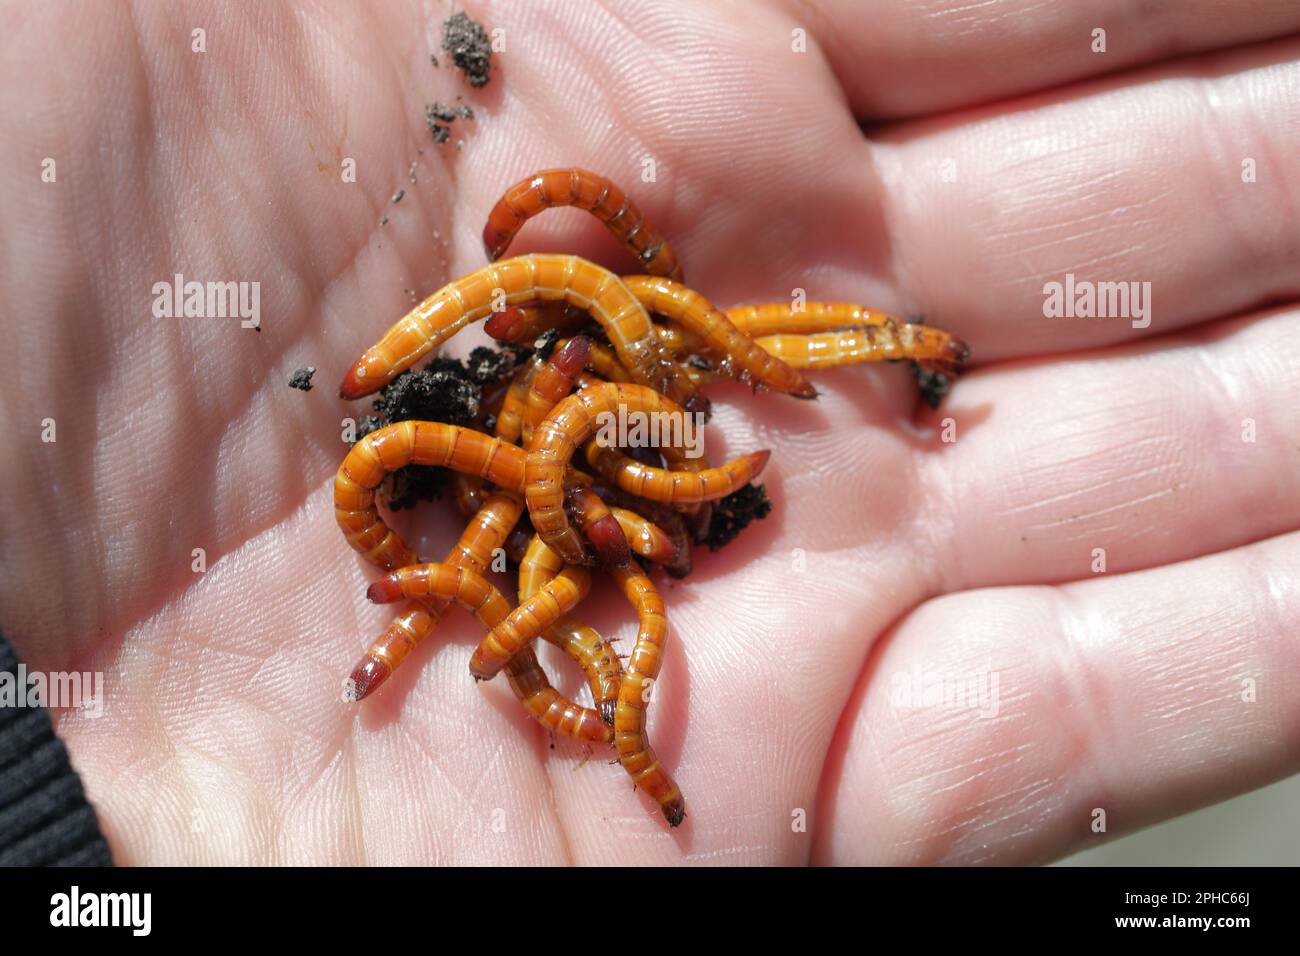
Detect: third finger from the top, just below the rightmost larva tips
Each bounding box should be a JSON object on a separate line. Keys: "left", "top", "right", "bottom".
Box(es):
{"left": 917, "top": 310, "right": 1300, "bottom": 593}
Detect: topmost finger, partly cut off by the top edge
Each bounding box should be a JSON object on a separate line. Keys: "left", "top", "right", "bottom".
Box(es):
{"left": 790, "top": 0, "right": 1300, "bottom": 117}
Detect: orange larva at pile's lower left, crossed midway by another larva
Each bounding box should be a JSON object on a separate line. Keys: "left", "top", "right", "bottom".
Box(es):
{"left": 367, "top": 564, "right": 611, "bottom": 744}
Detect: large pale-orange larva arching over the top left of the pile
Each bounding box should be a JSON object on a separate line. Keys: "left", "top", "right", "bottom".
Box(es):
{"left": 339, "top": 255, "right": 694, "bottom": 403}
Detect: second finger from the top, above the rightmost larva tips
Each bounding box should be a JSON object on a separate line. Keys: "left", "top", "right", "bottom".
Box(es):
{"left": 873, "top": 34, "right": 1300, "bottom": 360}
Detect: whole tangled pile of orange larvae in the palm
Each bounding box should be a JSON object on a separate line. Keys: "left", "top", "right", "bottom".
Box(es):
{"left": 334, "top": 169, "right": 967, "bottom": 826}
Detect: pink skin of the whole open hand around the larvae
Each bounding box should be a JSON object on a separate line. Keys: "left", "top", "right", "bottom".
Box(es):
{"left": 0, "top": 0, "right": 1300, "bottom": 864}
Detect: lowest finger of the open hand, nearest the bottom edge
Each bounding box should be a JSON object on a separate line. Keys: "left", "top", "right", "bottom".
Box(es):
{"left": 815, "top": 535, "right": 1300, "bottom": 864}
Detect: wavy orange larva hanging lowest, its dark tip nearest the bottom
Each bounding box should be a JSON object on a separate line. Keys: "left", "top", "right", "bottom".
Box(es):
{"left": 610, "top": 567, "right": 686, "bottom": 826}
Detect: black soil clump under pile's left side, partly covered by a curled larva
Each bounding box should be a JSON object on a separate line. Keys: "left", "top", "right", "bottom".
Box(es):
{"left": 356, "top": 347, "right": 528, "bottom": 511}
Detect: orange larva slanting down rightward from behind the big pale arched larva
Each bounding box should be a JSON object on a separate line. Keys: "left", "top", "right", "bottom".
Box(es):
{"left": 623, "top": 276, "right": 816, "bottom": 398}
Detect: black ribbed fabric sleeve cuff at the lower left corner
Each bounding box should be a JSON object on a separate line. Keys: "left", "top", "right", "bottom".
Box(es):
{"left": 0, "top": 635, "right": 113, "bottom": 866}
